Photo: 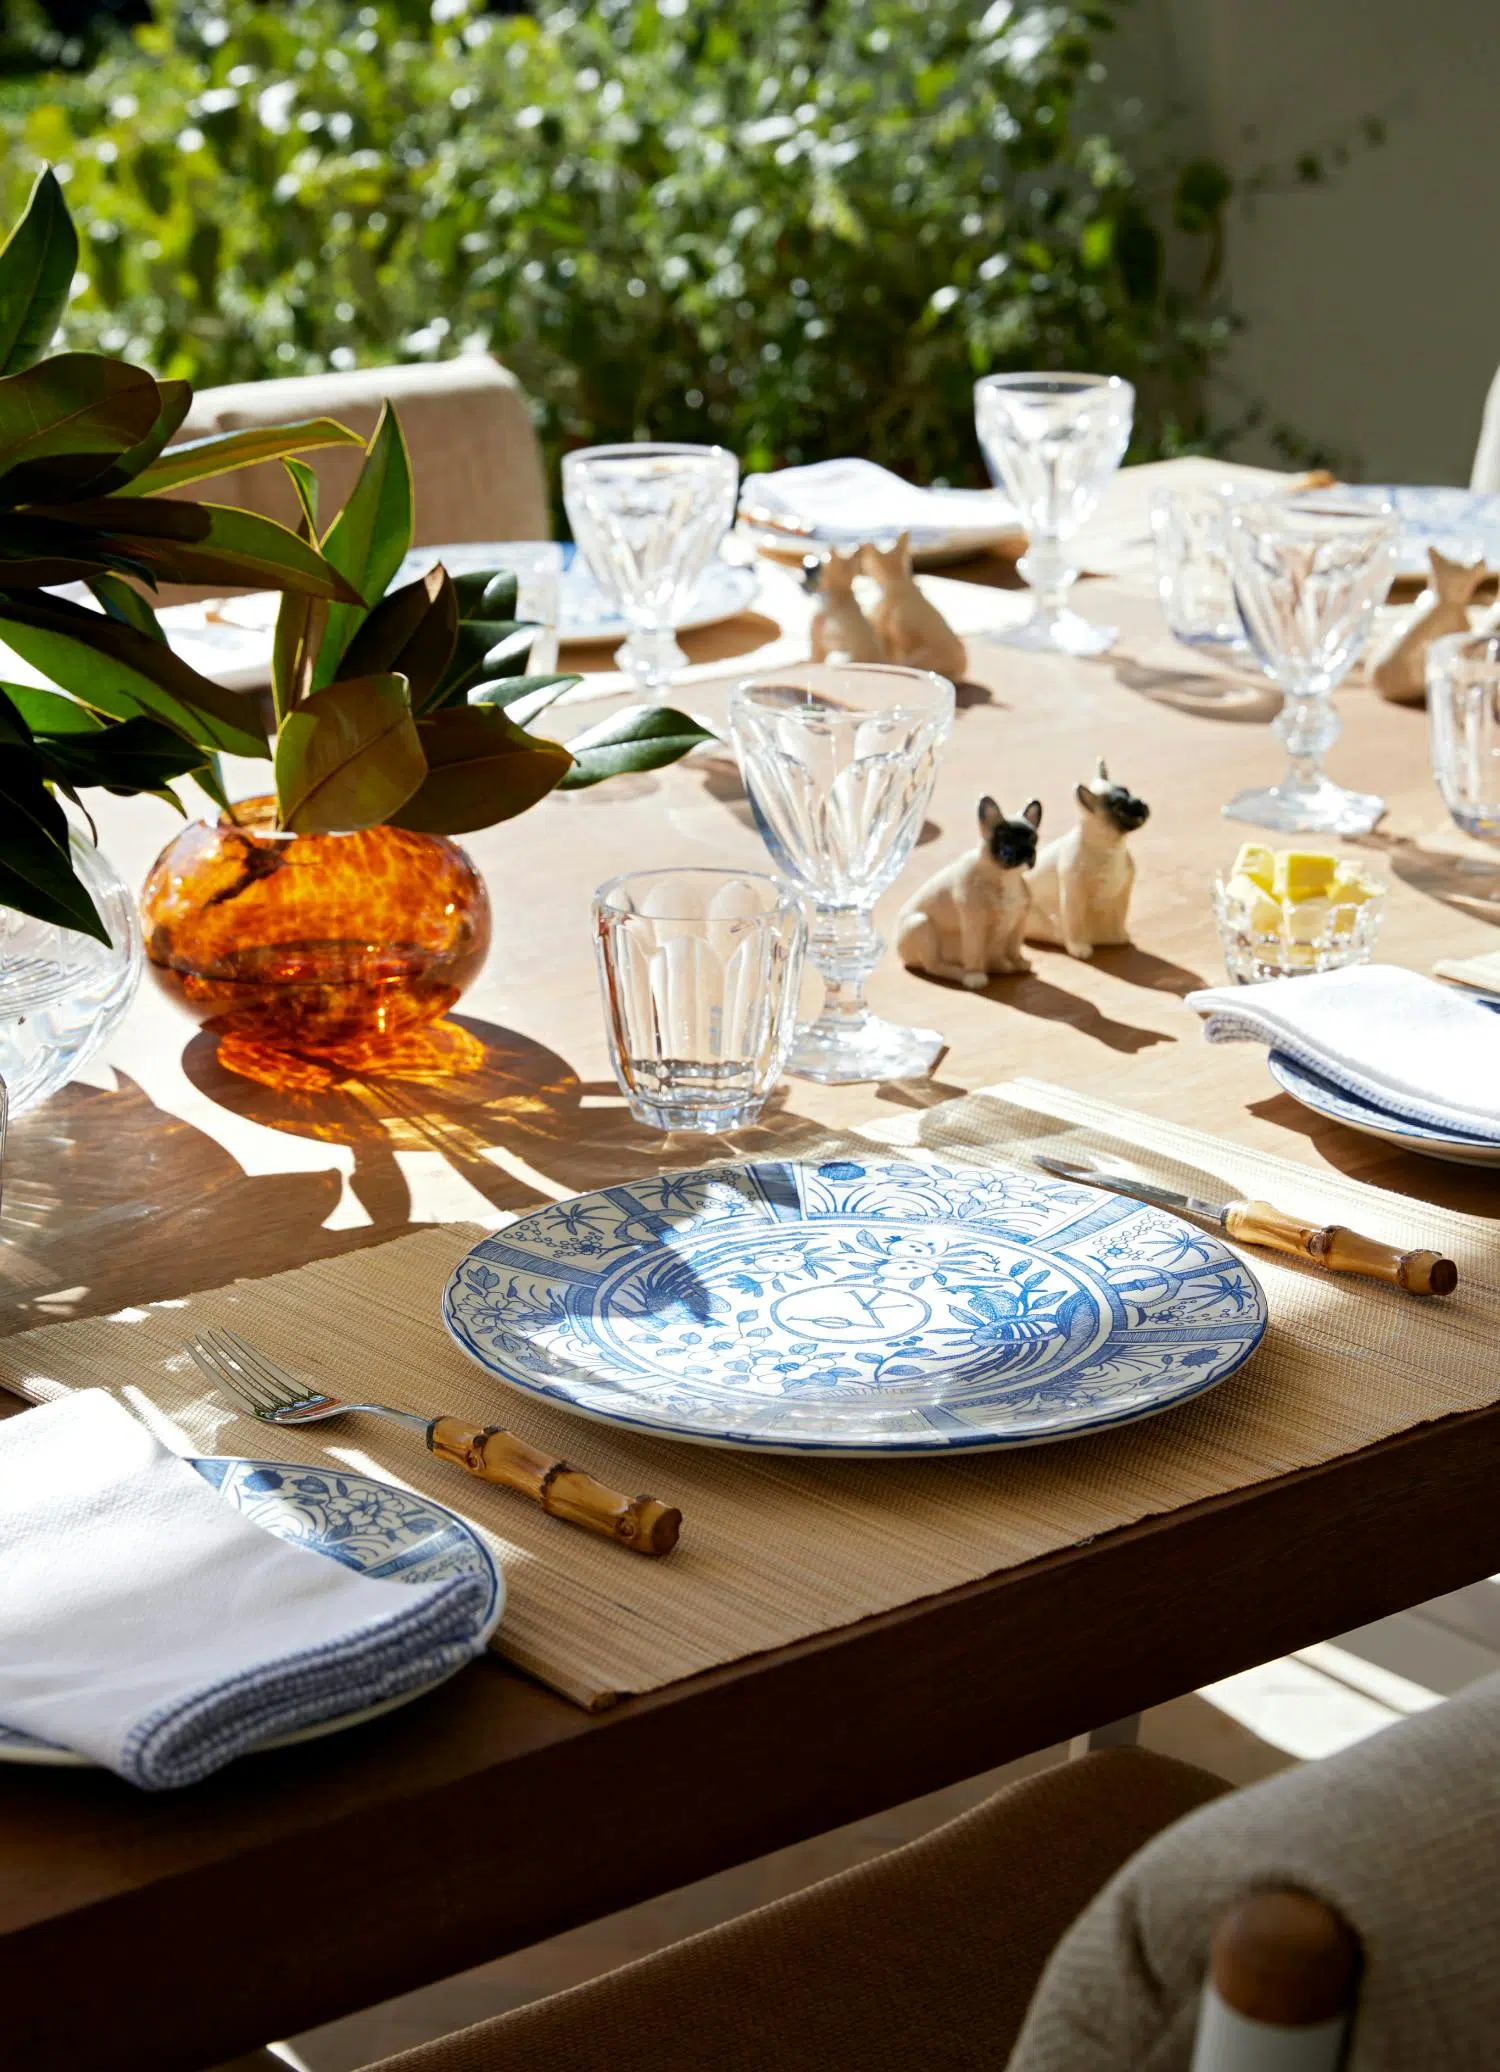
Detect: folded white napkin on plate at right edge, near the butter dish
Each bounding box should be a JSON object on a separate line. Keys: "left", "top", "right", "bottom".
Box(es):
{"left": 1187, "top": 963, "right": 1500, "bottom": 1144}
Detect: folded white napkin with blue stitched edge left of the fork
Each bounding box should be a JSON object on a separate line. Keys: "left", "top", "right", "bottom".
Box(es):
{"left": 0, "top": 1388, "right": 487, "bottom": 1790}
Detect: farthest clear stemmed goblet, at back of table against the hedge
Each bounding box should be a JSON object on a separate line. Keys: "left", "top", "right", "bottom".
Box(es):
{"left": 974, "top": 375, "right": 1135, "bottom": 655}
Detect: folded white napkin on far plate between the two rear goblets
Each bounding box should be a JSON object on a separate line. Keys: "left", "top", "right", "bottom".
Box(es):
{"left": 740, "top": 460, "right": 1019, "bottom": 547}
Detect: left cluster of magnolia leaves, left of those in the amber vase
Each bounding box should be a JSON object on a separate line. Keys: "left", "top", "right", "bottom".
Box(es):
{"left": 0, "top": 172, "right": 358, "bottom": 941}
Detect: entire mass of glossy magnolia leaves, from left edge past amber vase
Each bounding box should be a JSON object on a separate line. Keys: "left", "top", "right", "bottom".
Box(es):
{"left": 0, "top": 172, "right": 706, "bottom": 941}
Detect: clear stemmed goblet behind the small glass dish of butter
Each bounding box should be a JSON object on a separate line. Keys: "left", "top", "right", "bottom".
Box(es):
{"left": 1224, "top": 493, "right": 1398, "bottom": 835}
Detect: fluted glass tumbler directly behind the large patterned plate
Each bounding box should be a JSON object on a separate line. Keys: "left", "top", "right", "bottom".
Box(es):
{"left": 595, "top": 868, "right": 806, "bottom": 1133}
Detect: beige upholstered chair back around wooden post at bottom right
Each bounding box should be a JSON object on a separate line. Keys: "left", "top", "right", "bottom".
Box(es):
{"left": 1009, "top": 1676, "right": 1500, "bottom": 2072}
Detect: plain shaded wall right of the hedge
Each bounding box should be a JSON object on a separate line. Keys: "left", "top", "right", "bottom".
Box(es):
{"left": 1121, "top": 0, "right": 1500, "bottom": 483}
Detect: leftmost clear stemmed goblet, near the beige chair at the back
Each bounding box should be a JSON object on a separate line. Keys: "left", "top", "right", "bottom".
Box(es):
{"left": 564, "top": 441, "right": 740, "bottom": 696}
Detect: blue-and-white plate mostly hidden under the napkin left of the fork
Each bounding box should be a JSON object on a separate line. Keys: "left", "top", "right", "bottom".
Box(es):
{"left": 0, "top": 1459, "right": 506, "bottom": 1769}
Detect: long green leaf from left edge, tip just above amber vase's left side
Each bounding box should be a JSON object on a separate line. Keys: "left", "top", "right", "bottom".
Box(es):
{"left": 0, "top": 595, "right": 267, "bottom": 756}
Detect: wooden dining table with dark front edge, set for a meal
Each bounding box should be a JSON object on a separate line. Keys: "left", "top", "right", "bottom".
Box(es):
{"left": 0, "top": 470, "right": 1500, "bottom": 2072}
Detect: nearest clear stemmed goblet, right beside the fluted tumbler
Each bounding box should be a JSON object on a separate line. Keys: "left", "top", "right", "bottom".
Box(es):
{"left": 729, "top": 663, "right": 953, "bottom": 1080}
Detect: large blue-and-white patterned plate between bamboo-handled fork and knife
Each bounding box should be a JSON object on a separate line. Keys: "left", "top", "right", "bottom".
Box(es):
{"left": 443, "top": 1158, "right": 1266, "bottom": 1459}
